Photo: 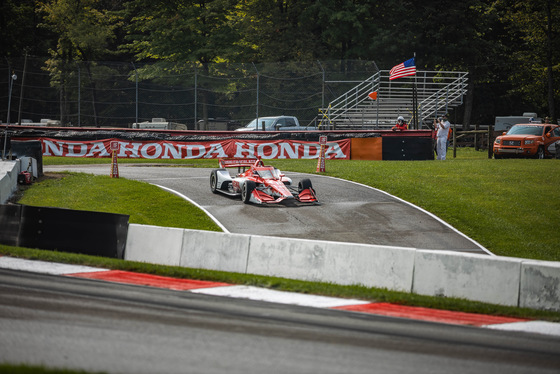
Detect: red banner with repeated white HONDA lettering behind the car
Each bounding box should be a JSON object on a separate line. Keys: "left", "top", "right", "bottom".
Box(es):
{"left": 33, "top": 138, "right": 350, "bottom": 160}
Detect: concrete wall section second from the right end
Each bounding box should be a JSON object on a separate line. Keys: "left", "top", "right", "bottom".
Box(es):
{"left": 412, "top": 250, "right": 522, "bottom": 306}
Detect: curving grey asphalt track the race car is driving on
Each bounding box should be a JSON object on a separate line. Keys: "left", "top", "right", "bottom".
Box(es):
{"left": 45, "top": 164, "right": 489, "bottom": 254}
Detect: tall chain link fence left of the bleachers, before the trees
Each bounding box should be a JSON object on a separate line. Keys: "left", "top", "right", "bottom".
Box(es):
{"left": 0, "top": 57, "right": 379, "bottom": 129}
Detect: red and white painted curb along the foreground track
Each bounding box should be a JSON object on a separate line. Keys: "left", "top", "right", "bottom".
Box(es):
{"left": 0, "top": 257, "right": 560, "bottom": 336}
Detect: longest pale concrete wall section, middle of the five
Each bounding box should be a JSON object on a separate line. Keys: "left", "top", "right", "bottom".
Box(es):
{"left": 247, "top": 236, "right": 415, "bottom": 292}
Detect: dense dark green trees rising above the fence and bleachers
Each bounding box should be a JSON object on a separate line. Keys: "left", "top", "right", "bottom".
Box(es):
{"left": 0, "top": 0, "right": 560, "bottom": 124}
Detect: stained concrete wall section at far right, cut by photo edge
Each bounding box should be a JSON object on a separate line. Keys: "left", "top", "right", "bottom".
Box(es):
{"left": 519, "top": 261, "right": 560, "bottom": 310}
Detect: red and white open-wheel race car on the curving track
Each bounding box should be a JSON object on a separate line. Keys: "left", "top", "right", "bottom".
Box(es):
{"left": 210, "top": 158, "right": 319, "bottom": 204}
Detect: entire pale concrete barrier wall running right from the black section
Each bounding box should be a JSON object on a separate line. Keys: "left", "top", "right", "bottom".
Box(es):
{"left": 125, "top": 224, "right": 560, "bottom": 310}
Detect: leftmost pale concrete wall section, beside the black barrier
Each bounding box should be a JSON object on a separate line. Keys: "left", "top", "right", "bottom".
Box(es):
{"left": 124, "top": 224, "right": 184, "bottom": 266}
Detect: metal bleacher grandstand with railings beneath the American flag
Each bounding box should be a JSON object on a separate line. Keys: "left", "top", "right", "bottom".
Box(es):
{"left": 320, "top": 70, "right": 468, "bottom": 129}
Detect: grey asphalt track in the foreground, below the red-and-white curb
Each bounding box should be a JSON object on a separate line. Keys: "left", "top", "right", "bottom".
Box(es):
{"left": 0, "top": 270, "right": 560, "bottom": 374}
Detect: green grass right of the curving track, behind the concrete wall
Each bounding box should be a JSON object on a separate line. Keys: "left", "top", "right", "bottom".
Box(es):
{"left": 318, "top": 159, "right": 560, "bottom": 261}
